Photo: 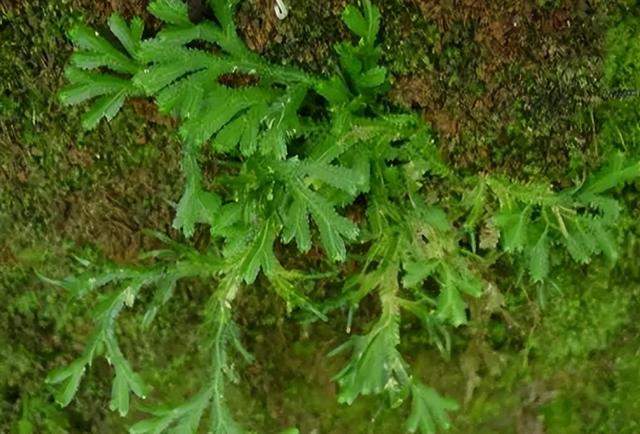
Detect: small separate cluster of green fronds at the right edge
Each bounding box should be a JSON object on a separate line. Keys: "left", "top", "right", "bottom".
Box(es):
{"left": 465, "top": 153, "right": 640, "bottom": 282}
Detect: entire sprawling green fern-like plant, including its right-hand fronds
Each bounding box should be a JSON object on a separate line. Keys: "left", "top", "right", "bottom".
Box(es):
{"left": 48, "top": 0, "right": 638, "bottom": 434}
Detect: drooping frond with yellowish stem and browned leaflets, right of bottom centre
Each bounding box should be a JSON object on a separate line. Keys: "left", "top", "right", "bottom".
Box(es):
{"left": 324, "top": 185, "right": 484, "bottom": 434}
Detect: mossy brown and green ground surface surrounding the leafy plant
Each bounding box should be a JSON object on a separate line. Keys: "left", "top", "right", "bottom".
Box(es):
{"left": 0, "top": 0, "right": 640, "bottom": 434}
